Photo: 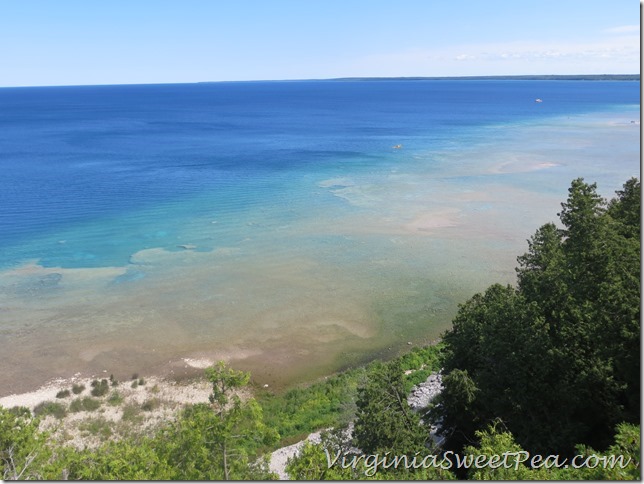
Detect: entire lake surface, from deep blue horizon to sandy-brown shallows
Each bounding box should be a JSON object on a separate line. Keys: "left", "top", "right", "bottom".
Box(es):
{"left": 0, "top": 81, "right": 639, "bottom": 393}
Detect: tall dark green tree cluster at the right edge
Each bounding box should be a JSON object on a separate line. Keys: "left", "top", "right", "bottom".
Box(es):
{"left": 435, "top": 179, "right": 640, "bottom": 453}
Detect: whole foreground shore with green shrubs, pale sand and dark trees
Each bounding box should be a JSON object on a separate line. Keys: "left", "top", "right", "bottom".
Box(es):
{"left": 0, "top": 178, "right": 641, "bottom": 480}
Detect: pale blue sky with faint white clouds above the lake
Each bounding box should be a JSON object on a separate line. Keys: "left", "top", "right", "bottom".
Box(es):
{"left": 0, "top": 0, "right": 640, "bottom": 87}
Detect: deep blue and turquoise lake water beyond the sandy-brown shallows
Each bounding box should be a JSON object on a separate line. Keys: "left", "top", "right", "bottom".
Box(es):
{"left": 0, "top": 81, "right": 639, "bottom": 267}
